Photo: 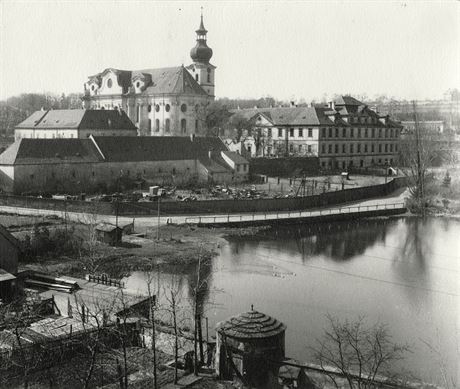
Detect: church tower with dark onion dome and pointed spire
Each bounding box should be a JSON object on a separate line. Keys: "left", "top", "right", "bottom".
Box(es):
{"left": 187, "top": 12, "right": 216, "bottom": 98}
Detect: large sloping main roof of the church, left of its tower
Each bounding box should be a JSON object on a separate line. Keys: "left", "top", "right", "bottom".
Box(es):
{"left": 89, "top": 66, "right": 207, "bottom": 97}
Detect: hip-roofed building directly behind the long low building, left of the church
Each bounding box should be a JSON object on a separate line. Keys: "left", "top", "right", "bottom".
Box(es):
{"left": 14, "top": 109, "right": 137, "bottom": 141}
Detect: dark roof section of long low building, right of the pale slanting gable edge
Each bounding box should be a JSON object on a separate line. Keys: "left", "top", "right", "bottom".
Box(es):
{"left": 94, "top": 136, "right": 227, "bottom": 162}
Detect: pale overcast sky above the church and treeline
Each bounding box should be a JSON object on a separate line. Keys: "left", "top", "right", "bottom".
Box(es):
{"left": 0, "top": 0, "right": 460, "bottom": 101}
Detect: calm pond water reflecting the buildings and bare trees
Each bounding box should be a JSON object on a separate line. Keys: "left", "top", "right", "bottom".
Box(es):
{"left": 127, "top": 218, "right": 460, "bottom": 380}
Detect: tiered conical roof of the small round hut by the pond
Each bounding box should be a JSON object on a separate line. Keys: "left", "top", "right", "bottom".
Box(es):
{"left": 217, "top": 310, "right": 286, "bottom": 339}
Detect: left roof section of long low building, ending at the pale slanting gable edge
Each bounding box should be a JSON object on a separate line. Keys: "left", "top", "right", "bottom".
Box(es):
{"left": 0, "top": 138, "right": 104, "bottom": 165}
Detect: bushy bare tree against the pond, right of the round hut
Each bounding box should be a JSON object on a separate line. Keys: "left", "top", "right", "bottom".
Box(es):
{"left": 312, "top": 315, "right": 410, "bottom": 389}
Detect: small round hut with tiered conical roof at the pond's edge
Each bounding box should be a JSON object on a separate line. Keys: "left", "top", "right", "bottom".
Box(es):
{"left": 216, "top": 309, "right": 286, "bottom": 388}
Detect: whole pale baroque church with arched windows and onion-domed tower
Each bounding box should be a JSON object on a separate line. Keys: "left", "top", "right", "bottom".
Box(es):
{"left": 82, "top": 15, "right": 216, "bottom": 136}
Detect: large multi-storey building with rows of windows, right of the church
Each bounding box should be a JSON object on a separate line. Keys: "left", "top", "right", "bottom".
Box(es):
{"left": 234, "top": 96, "right": 402, "bottom": 169}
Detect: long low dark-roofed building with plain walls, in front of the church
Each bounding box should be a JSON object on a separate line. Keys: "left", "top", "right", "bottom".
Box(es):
{"left": 0, "top": 136, "right": 249, "bottom": 193}
